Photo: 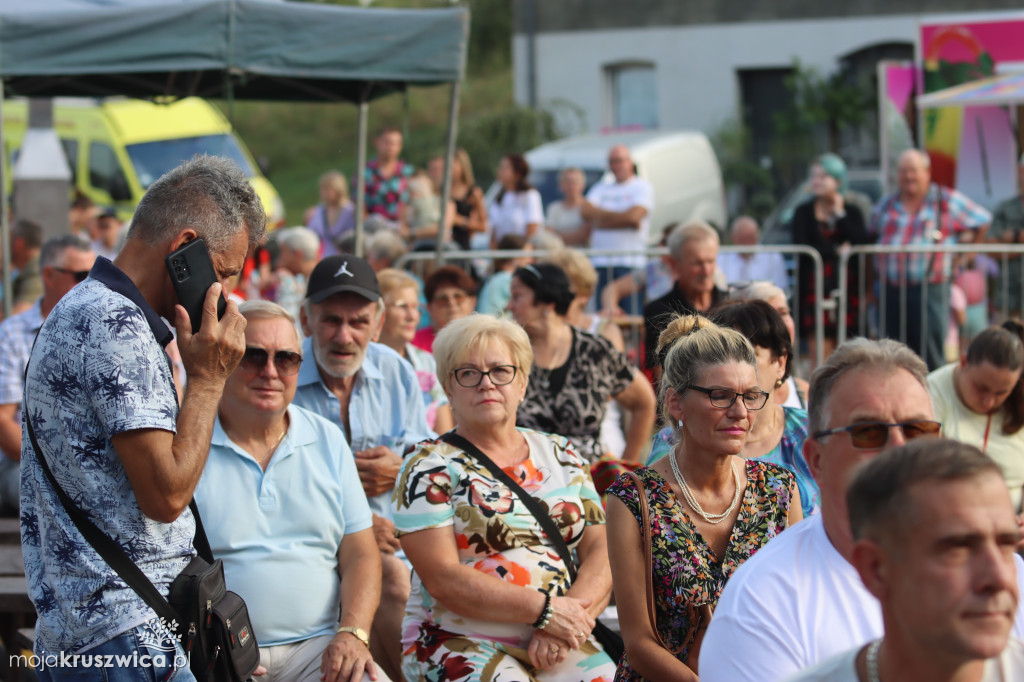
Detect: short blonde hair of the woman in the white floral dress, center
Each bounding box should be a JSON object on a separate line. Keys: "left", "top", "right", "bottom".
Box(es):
{"left": 434, "top": 312, "right": 534, "bottom": 393}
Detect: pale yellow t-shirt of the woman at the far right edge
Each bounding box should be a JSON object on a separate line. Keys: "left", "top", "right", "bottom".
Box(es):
{"left": 928, "top": 363, "right": 1024, "bottom": 511}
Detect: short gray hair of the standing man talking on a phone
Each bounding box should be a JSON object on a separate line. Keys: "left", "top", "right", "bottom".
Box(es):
{"left": 128, "top": 155, "right": 266, "bottom": 252}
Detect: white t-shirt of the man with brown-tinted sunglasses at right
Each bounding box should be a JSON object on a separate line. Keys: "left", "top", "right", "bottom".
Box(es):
{"left": 700, "top": 515, "right": 1024, "bottom": 682}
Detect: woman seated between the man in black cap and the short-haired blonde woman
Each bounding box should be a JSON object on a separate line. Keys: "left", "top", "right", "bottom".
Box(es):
{"left": 374, "top": 267, "right": 453, "bottom": 433}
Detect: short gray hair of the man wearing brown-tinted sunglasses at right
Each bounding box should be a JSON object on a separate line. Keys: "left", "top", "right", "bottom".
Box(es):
{"left": 807, "top": 338, "right": 928, "bottom": 434}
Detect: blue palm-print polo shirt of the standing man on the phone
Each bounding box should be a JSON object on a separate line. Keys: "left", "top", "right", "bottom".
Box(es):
{"left": 22, "top": 258, "right": 189, "bottom": 655}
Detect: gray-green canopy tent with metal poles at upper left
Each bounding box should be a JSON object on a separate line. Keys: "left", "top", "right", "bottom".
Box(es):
{"left": 0, "top": 0, "right": 469, "bottom": 309}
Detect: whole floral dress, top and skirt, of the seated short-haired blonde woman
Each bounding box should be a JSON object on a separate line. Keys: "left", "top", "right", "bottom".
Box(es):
{"left": 394, "top": 429, "right": 615, "bottom": 682}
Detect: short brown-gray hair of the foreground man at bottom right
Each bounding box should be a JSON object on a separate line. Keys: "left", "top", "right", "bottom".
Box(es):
{"left": 846, "top": 438, "right": 1002, "bottom": 549}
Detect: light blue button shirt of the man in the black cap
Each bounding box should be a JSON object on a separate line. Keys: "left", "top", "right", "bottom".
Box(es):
{"left": 294, "top": 338, "right": 436, "bottom": 519}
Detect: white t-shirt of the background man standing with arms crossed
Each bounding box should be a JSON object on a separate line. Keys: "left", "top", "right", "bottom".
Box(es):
{"left": 587, "top": 175, "right": 654, "bottom": 267}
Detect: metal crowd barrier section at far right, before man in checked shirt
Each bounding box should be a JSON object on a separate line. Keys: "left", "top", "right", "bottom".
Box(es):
{"left": 829, "top": 244, "right": 1024, "bottom": 356}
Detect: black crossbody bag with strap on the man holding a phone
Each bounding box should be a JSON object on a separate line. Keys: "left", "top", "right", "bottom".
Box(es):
{"left": 25, "top": 410, "right": 259, "bottom": 682}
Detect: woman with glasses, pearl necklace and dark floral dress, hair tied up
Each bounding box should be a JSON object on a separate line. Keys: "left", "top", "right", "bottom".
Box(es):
{"left": 607, "top": 315, "right": 803, "bottom": 680}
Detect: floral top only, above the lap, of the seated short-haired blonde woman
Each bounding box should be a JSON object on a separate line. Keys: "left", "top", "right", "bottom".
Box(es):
{"left": 394, "top": 429, "right": 604, "bottom": 647}
